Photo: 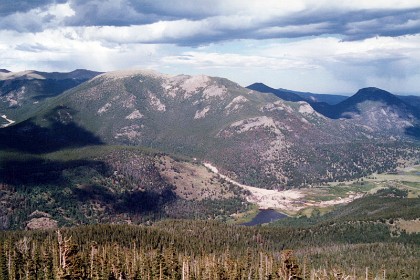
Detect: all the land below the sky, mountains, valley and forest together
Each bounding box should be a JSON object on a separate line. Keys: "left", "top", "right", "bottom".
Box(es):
{"left": 0, "top": 70, "right": 420, "bottom": 279}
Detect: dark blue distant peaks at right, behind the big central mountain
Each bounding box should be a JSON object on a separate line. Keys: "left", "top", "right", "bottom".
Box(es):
{"left": 248, "top": 83, "right": 420, "bottom": 131}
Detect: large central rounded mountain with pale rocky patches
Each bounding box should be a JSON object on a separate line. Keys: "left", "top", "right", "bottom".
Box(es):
{"left": 0, "top": 70, "right": 412, "bottom": 188}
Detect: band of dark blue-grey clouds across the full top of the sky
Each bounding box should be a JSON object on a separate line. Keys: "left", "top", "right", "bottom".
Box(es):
{"left": 0, "top": 0, "right": 420, "bottom": 46}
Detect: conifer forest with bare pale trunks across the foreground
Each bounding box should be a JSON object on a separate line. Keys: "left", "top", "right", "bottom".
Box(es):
{"left": 0, "top": 220, "right": 420, "bottom": 279}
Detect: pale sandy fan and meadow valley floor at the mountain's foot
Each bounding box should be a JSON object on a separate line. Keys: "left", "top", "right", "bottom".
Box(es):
{"left": 203, "top": 163, "right": 420, "bottom": 217}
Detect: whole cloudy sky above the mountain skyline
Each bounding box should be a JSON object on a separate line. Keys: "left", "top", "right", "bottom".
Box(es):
{"left": 0, "top": 0, "right": 420, "bottom": 95}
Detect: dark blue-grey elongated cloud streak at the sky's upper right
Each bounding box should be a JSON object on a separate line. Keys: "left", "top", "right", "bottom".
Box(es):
{"left": 252, "top": 9, "right": 420, "bottom": 40}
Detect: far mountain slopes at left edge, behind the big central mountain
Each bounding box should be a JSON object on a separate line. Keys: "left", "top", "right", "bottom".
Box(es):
{"left": 0, "top": 69, "right": 101, "bottom": 120}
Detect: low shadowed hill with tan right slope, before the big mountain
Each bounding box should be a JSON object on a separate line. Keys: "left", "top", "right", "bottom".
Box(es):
{"left": 0, "top": 146, "right": 248, "bottom": 229}
